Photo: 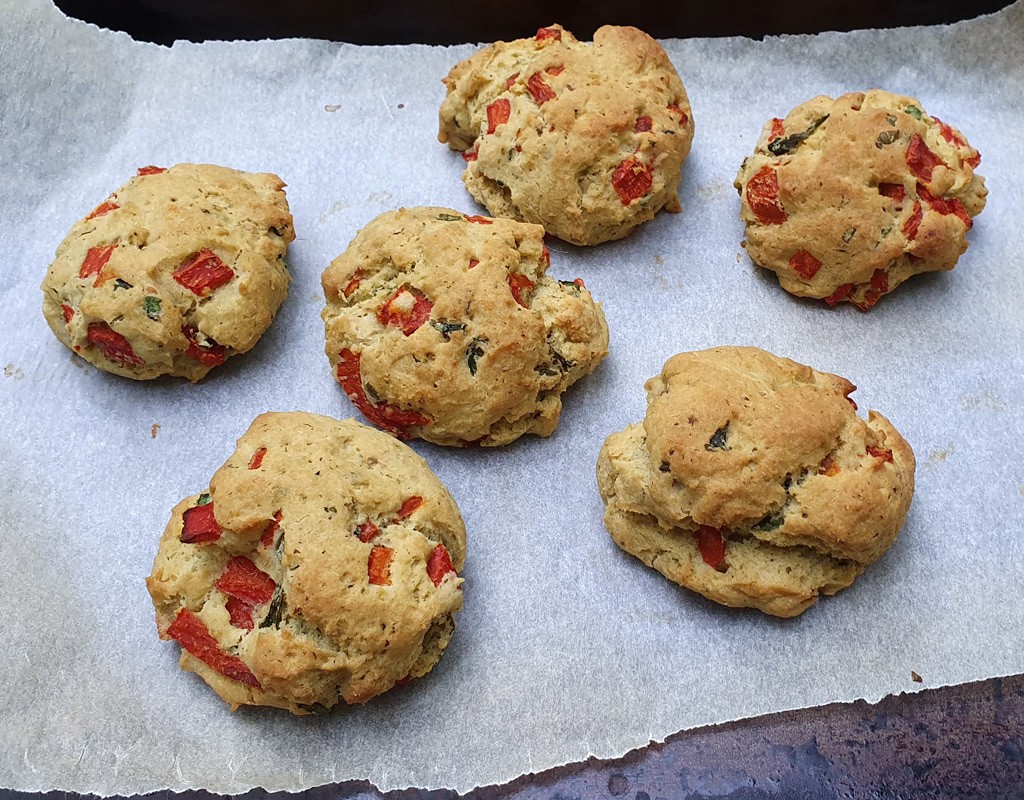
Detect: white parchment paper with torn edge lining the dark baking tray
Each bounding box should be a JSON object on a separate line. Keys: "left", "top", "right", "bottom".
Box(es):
{"left": 0, "top": 0, "right": 1024, "bottom": 795}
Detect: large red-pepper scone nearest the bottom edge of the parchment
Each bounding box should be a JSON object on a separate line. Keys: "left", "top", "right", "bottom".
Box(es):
{"left": 146, "top": 412, "right": 466, "bottom": 714}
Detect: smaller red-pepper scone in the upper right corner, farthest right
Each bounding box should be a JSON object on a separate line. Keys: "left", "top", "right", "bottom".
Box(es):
{"left": 735, "top": 89, "right": 988, "bottom": 310}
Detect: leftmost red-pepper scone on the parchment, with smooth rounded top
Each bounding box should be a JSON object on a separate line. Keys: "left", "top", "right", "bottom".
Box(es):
{"left": 42, "top": 164, "right": 295, "bottom": 381}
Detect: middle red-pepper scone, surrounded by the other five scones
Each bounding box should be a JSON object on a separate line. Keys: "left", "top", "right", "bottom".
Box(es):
{"left": 323, "top": 208, "right": 608, "bottom": 447}
